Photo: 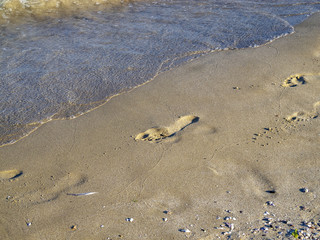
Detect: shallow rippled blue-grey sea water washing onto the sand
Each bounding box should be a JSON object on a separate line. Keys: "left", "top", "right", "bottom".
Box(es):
{"left": 0, "top": 0, "right": 320, "bottom": 145}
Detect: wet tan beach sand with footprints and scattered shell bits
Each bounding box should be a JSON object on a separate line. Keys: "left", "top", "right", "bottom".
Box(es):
{"left": 0, "top": 14, "right": 320, "bottom": 240}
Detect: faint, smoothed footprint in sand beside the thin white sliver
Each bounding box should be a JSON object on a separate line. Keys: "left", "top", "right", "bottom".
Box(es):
{"left": 16, "top": 173, "right": 87, "bottom": 204}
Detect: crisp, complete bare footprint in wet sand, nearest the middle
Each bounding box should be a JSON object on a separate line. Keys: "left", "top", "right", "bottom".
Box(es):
{"left": 135, "top": 115, "right": 199, "bottom": 142}
